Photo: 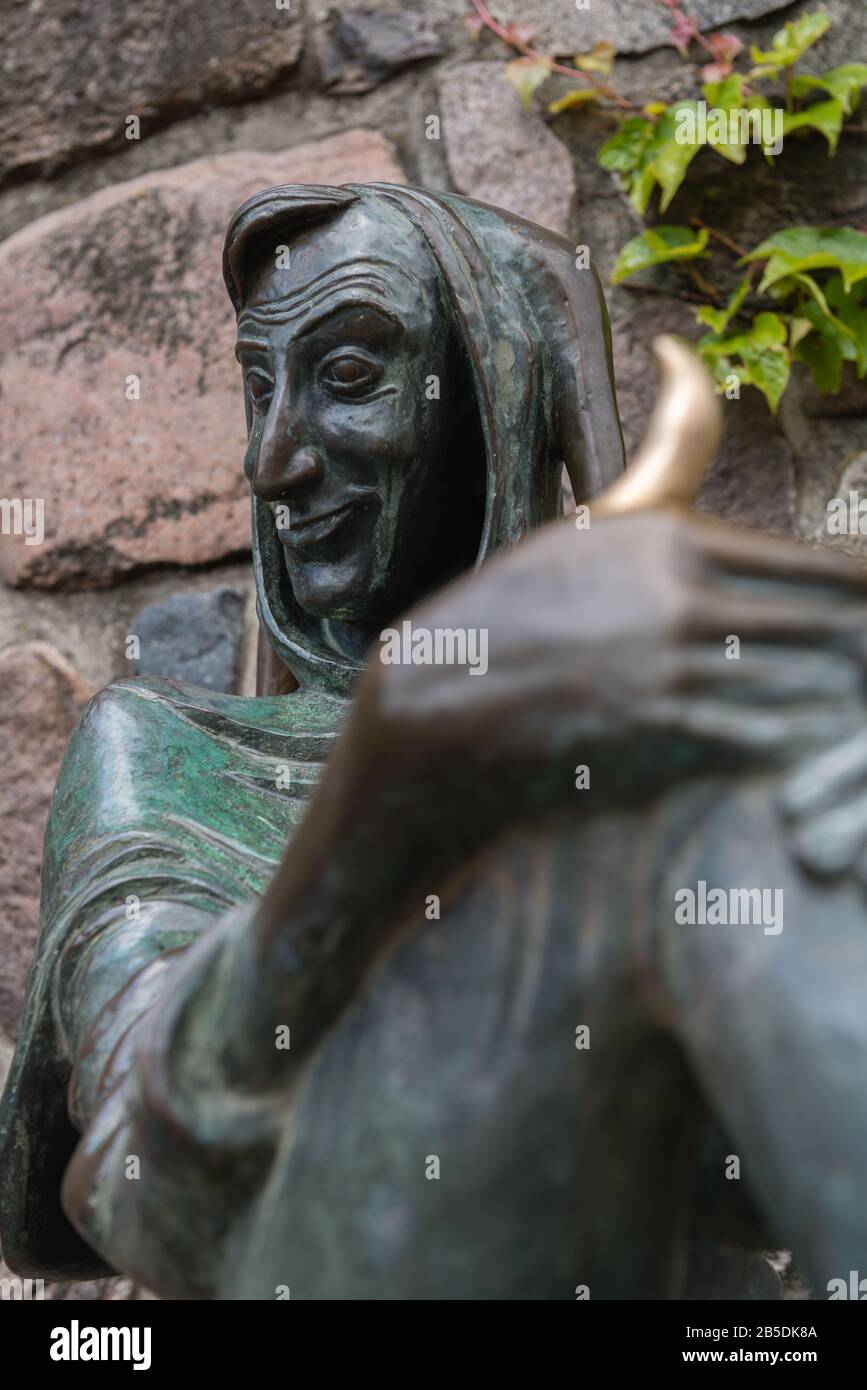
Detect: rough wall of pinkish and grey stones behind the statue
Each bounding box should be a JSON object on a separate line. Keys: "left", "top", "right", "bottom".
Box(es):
{"left": 0, "top": 0, "right": 867, "bottom": 1297}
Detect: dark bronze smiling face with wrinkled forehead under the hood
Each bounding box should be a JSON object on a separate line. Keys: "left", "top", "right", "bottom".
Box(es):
{"left": 238, "top": 207, "right": 478, "bottom": 623}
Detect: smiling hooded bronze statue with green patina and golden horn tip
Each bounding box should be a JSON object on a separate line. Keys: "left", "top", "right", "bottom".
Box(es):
{"left": 0, "top": 185, "right": 867, "bottom": 1298}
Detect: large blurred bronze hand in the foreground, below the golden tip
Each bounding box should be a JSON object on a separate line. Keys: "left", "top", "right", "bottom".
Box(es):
{"left": 371, "top": 510, "right": 867, "bottom": 806}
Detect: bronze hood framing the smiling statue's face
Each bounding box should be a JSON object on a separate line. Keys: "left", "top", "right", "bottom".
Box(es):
{"left": 224, "top": 183, "right": 624, "bottom": 695}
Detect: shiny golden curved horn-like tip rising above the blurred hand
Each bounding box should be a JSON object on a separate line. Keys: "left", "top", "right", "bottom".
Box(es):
{"left": 591, "top": 335, "right": 723, "bottom": 516}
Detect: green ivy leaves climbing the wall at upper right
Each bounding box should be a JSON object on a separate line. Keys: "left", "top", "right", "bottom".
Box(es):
{"left": 468, "top": 0, "right": 867, "bottom": 413}
